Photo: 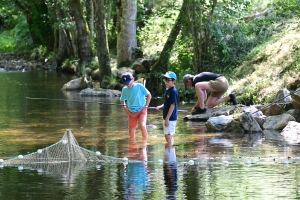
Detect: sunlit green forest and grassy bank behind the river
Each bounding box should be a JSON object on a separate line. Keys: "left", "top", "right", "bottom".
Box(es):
{"left": 0, "top": 0, "right": 300, "bottom": 104}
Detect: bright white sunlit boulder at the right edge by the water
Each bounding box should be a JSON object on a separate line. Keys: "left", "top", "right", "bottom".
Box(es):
{"left": 280, "top": 121, "right": 300, "bottom": 144}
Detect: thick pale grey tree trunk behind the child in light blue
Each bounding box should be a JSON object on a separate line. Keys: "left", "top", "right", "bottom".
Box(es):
{"left": 117, "top": 0, "right": 137, "bottom": 67}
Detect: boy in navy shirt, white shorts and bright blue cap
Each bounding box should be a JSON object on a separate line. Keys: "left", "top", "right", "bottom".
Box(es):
{"left": 156, "top": 72, "right": 178, "bottom": 145}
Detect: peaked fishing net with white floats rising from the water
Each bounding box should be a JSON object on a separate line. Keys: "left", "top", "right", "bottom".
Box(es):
{"left": 4, "top": 129, "right": 123, "bottom": 166}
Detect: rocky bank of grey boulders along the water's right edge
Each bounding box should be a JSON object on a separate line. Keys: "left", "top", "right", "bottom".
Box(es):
{"left": 184, "top": 88, "right": 300, "bottom": 144}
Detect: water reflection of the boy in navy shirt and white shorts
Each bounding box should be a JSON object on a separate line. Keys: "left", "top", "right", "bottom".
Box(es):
{"left": 164, "top": 143, "right": 177, "bottom": 199}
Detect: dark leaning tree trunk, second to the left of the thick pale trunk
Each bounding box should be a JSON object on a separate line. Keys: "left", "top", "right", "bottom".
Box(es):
{"left": 69, "top": 0, "right": 93, "bottom": 74}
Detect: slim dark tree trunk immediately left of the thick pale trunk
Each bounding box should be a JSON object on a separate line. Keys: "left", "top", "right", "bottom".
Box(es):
{"left": 95, "top": 0, "right": 111, "bottom": 84}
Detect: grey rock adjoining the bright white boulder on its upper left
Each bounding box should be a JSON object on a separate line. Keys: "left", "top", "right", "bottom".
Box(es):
{"left": 263, "top": 114, "right": 296, "bottom": 130}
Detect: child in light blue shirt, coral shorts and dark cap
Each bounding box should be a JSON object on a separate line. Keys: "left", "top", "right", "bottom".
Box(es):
{"left": 120, "top": 73, "right": 152, "bottom": 141}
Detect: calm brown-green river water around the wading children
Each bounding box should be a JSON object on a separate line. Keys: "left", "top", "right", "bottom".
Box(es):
{"left": 0, "top": 71, "right": 300, "bottom": 200}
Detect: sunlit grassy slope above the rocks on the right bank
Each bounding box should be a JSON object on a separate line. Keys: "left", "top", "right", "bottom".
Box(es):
{"left": 229, "top": 18, "right": 300, "bottom": 105}
